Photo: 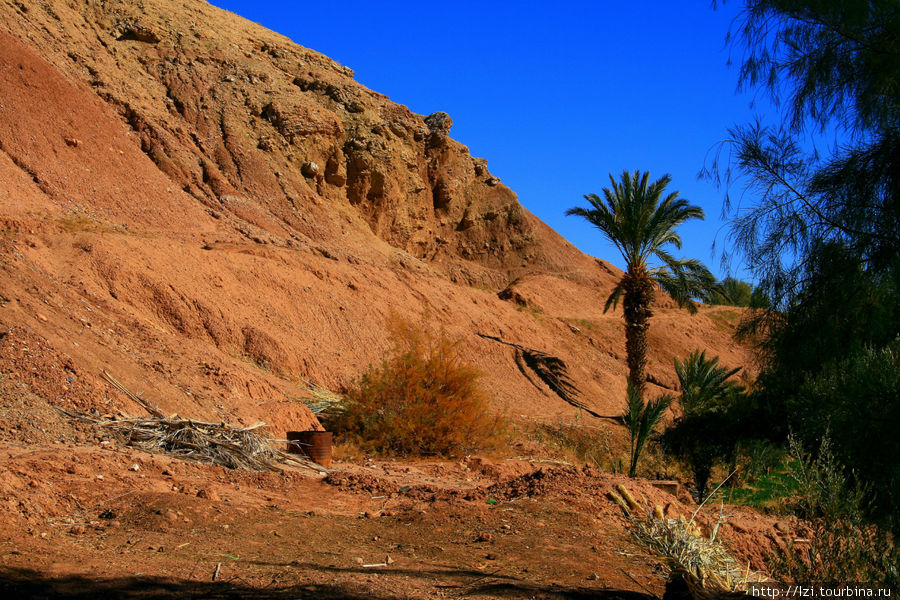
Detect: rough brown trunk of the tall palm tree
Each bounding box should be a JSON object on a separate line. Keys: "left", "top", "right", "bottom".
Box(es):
{"left": 622, "top": 269, "right": 653, "bottom": 396}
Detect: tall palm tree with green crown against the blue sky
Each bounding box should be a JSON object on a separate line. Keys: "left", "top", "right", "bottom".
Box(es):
{"left": 566, "top": 171, "right": 718, "bottom": 396}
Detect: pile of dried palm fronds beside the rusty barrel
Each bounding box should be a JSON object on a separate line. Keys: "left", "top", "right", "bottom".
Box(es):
{"left": 56, "top": 371, "right": 324, "bottom": 471}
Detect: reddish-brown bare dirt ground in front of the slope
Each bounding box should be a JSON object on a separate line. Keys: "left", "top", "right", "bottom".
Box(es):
{"left": 0, "top": 422, "right": 787, "bottom": 598}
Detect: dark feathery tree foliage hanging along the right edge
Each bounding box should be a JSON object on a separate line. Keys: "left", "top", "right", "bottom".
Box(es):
{"left": 709, "top": 0, "right": 900, "bottom": 515}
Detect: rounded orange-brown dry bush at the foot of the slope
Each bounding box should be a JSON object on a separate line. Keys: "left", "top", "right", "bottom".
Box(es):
{"left": 329, "top": 317, "right": 504, "bottom": 456}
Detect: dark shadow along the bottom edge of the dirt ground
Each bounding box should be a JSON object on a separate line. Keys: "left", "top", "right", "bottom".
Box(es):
{"left": 0, "top": 567, "right": 654, "bottom": 600}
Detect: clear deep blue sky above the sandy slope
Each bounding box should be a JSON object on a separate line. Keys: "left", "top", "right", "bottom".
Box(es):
{"left": 207, "top": 0, "right": 775, "bottom": 277}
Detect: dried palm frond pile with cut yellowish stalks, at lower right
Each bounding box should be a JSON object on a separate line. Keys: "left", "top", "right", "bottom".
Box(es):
{"left": 609, "top": 485, "right": 766, "bottom": 600}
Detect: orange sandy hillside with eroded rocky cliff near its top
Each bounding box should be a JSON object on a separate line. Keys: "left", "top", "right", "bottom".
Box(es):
{"left": 0, "top": 0, "right": 747, "bottom": 434}
